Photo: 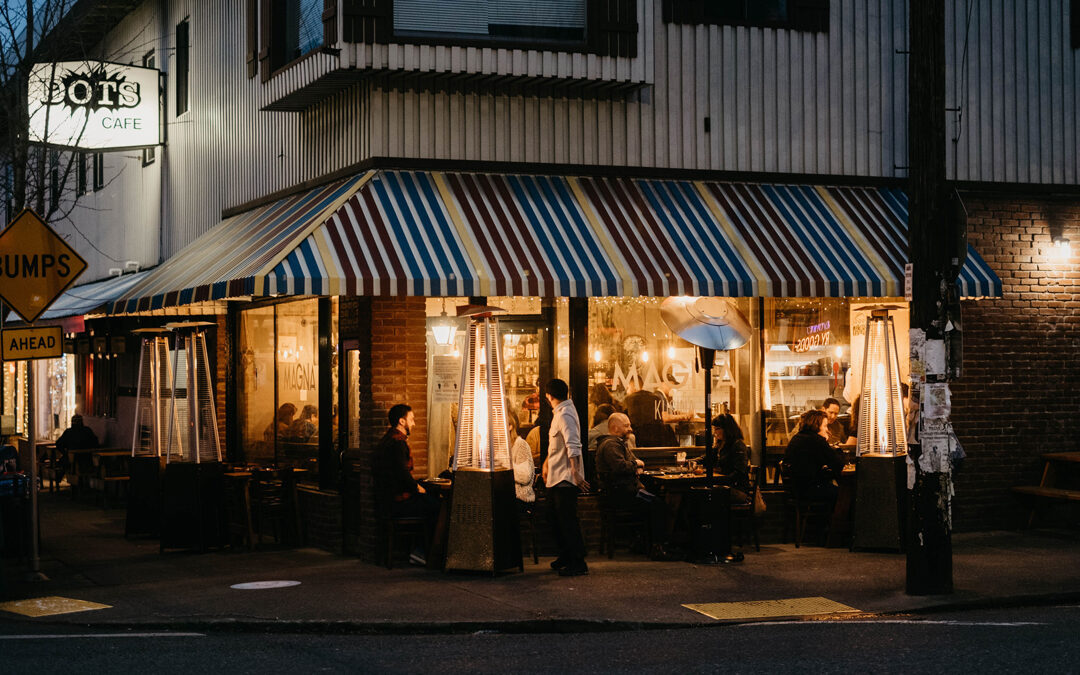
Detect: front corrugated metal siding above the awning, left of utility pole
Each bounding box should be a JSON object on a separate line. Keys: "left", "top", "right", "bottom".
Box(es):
{"left": 365, "top": 0, "right": 907, "bottom": 176}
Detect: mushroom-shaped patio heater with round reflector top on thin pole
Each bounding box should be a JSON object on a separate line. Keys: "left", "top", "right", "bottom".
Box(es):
{"left": 660, "top": 296, "right": 753, "bottom": 565}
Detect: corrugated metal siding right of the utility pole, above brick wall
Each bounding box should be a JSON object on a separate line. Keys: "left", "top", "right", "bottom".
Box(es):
{"left": 946, "top": 0, "right": 1080, "bottom": 185}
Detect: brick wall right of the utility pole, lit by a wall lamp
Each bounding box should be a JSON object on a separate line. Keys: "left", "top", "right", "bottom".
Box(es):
{"left": 951, "top": 194, "right": 1080, "bottom": 530}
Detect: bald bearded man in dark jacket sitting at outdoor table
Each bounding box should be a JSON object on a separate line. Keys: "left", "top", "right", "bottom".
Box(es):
{"left": 596, "top": 413, "right": 673, "bottom": 561}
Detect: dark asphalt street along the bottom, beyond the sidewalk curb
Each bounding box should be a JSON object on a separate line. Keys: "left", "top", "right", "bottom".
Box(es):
{"left": 0, "top": 605, "right": 1080, "bottom": 674}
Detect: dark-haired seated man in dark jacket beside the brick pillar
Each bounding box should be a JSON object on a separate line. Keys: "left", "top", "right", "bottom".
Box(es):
{"left": 372, "top": 403, "right": 438, "bottom": 565}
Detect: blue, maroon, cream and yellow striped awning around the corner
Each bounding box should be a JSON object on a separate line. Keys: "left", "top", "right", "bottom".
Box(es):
{"left": 114, "top": 171, "right": 1001, "bottom": 311}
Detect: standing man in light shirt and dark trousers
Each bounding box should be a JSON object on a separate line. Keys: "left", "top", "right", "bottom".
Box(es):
{"left": 543, "top": 378, "right": 589, "bottom": 577}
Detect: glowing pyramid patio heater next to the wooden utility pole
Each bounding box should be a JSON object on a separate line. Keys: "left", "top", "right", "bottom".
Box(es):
{"left": 851, "top": 305, "right": 907, "bottom": 551}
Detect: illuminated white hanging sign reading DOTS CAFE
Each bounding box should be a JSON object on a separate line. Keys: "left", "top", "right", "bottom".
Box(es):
{"left": 27, "top": 60, "right": 161, "bottom": 150}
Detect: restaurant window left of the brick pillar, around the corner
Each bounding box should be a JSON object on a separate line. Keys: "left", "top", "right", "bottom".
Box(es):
{"left": 237, "top": 298, "right": 337, "bottom": 480}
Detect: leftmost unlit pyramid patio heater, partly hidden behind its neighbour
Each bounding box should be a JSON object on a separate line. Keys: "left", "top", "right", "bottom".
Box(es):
{"left": 124, "top": 328, "right": 173, "bottom": 537}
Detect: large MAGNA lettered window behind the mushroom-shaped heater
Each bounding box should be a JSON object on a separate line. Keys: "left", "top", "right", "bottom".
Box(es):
{"left": 588, "top": 298, "right": 755, "bottom": 447}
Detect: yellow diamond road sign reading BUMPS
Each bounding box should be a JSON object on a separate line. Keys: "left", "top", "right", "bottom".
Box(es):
{"left": 0, "top": 210, "right": 86, "bottom": 323}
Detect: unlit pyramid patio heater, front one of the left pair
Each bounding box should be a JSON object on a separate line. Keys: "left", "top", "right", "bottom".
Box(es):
{"left": 160, "top": 321, "right": 228, "bottom": 551}
